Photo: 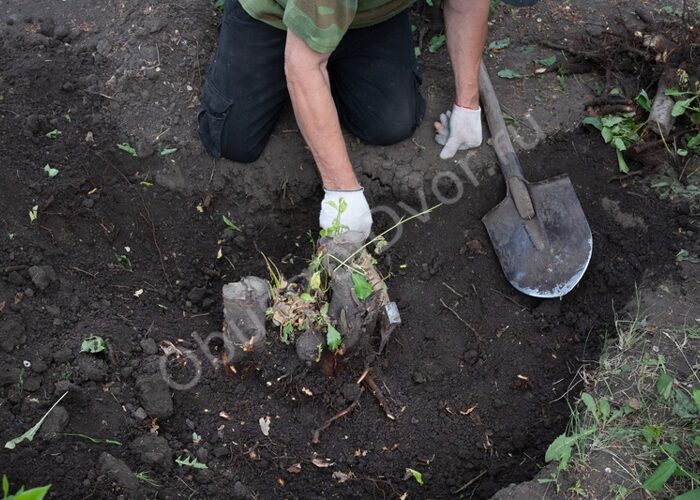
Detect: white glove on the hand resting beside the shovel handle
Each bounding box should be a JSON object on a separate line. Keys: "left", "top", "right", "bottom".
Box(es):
{"left": 435, "top": 104, "right": 481, "bottom": 160}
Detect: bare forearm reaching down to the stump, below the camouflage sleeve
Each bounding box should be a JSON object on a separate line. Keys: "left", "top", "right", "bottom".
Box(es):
{"left": 286, "top": 34, "right": 359, "bottom": 190}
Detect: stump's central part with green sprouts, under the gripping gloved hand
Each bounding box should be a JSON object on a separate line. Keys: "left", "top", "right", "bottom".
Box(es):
{"left": 264, "top": 202, "right": 436, "bottom": 361}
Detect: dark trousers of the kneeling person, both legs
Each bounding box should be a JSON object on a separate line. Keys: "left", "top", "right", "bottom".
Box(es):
{"left": 198, "top": 0, "right": 425, "bottom": 163}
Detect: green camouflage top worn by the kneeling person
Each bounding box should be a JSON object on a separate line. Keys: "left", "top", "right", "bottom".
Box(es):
{"left": 241, "top": 0, "right": 415, "bottom": 53}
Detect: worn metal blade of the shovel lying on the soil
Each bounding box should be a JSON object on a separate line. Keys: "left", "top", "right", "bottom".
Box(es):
{"left": 481, "top": 175, "right": 593, "bottom": 298}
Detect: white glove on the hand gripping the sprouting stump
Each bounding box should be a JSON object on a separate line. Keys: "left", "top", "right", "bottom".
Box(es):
{"left": 319, "top": 188, "right": 372, "bottom": 239}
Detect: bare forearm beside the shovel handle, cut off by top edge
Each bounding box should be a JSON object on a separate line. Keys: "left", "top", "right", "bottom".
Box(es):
{"left": 444, "top": 0, "right": 489, "bottom": 108}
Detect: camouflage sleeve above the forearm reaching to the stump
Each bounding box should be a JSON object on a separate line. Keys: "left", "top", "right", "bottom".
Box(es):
{"left": 282, "top": 0, "right": 357, "bottom": 54}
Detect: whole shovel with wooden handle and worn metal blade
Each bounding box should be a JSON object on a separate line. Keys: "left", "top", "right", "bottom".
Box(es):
{"left": 479, "top": 61, "right": 593, "bottom": 298}
